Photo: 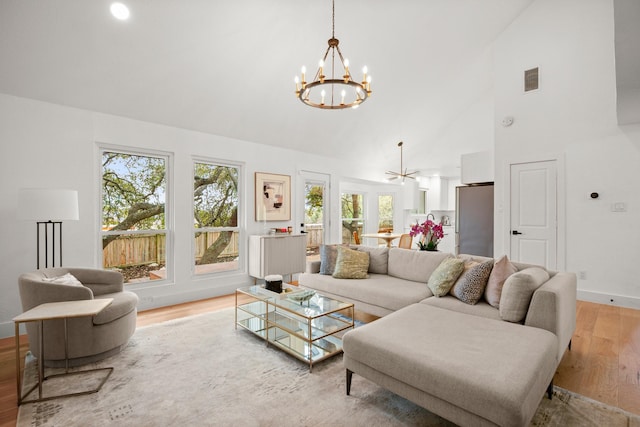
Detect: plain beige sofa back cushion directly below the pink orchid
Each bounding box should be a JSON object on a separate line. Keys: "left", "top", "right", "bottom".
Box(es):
{"left": 388, "top": 248, "right": 452, "bottom": 283}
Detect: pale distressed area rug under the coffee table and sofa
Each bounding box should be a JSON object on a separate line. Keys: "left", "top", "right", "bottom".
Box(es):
{"left": 17, "top": 309, "right": 640, "bottom": 427}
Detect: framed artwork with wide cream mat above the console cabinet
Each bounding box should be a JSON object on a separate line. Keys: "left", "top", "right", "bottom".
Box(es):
{"left": 255, "top": 172, "right": 291, "bottom": 221}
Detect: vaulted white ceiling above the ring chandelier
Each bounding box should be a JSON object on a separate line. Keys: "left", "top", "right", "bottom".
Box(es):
{"left": 0, "top": 0, "right": 532, "bottom": 174}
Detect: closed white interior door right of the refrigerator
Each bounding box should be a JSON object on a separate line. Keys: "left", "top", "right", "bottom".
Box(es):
{"left": 510, "top": 160, "right": 558, "bottom": 270}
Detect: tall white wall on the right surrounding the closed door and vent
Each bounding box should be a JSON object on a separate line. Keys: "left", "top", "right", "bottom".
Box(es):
{"left": 494, "top": 0, "right": 640, "bottom": 307}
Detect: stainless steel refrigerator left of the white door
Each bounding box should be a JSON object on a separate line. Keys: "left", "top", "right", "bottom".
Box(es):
{"left": 456, "top": 184, "right": 493, "bottom": 257}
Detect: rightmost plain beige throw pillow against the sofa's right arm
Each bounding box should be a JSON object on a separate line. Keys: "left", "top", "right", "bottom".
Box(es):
{"left": 500, "top": 267, "right": 549, "bottom": 322}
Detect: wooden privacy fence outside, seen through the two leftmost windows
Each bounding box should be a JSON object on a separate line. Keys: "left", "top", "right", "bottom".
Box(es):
{"left": 102, "top": 231, "right": 238, "bottom": 268}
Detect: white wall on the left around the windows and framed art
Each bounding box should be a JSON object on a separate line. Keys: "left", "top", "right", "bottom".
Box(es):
{"left": 0, "top": 94, "right": 376, "bottom": 337}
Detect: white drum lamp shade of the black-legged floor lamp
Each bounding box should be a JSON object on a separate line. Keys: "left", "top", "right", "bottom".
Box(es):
{"left": 18, "top": 188, "right": 79, "bottom": 221}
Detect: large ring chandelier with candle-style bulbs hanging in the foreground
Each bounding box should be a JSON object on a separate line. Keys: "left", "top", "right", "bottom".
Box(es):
{"left": 295, "top": 0, "right": 371, "bottom": 110}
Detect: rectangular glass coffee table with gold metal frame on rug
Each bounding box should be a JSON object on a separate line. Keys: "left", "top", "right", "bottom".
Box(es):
{"left": 235, "top": 285, "right": 354, "bottom": 371}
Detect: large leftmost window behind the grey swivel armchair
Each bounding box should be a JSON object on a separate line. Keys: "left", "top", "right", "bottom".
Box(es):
{"left": 101, "top": 149, "right": 169, "bottom": 283}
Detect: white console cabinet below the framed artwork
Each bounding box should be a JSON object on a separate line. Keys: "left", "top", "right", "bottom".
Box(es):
{"left": 249, "top": 234, "right": 307, "bottom": 279}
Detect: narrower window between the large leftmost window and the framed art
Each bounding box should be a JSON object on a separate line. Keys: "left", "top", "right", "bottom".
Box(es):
{"left": 193, "top": 162, "right": 240, "bottom": 274}
